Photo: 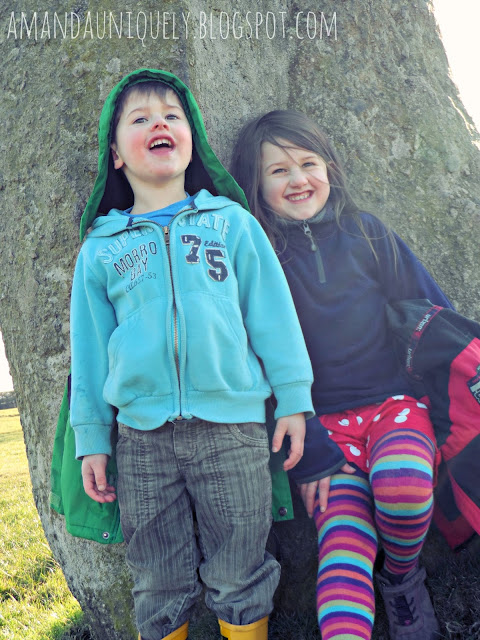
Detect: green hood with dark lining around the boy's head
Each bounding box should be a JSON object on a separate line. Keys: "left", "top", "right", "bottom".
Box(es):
{"left": 80, "top": 69, "right": 248, "bottom": 239}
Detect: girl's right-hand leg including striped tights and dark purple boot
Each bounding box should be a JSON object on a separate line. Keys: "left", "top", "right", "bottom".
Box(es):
{"left": 370, "top": 408, "right": 439, "bottom": 640}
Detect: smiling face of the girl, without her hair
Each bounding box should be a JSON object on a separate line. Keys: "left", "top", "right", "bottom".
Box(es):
{"left": 260, "top": 140, "right": 330, "bottom": 220}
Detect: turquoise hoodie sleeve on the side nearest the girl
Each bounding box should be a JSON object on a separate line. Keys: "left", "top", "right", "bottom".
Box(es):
{"left": 234, "top": 214, "right": 313, "bottom": 418}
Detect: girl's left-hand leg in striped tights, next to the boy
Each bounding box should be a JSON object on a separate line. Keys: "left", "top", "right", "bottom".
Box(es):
{"left": 314, "top": 471, "right": 377, "bottom": 640}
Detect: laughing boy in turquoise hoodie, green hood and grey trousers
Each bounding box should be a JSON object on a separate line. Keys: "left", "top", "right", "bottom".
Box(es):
{"left": 71, "top": 69, "right": 312, "bottom": 640}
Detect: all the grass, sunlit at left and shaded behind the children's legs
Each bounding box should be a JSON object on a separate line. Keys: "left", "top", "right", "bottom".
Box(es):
{"left": 0, "top": 409, "right": 480, "bottom": 640}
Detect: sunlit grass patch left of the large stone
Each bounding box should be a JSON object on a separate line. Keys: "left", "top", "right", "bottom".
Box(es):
{"left": 0, "top": 409, "right": 90, "bottom": 640}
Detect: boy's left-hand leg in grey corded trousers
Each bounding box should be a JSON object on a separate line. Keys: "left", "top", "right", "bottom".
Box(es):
{"left": 117, "top": 424, "right": 201, "bottom": 640}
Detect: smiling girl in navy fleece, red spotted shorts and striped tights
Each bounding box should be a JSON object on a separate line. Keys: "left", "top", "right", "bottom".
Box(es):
{"left": 232, "top": 111, "right": 451, "bottom": 640}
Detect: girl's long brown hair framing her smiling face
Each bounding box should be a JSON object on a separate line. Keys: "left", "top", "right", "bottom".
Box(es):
{"left": 230, "top": 110, "right": 394, "bottom": 258}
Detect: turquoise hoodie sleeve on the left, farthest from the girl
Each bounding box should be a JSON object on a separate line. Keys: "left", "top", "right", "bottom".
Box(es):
{"left": 70, "top": 245, "right": 116, "bottom": 458}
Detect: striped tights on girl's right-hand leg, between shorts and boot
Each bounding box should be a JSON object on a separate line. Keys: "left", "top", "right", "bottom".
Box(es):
{"left": 370, "top": 429, "right": 435, "bottom": 577}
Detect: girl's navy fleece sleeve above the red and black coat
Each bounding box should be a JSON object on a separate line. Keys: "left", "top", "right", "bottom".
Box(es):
{"left": 367, "top": 216, "right": 453, "bottom": 309}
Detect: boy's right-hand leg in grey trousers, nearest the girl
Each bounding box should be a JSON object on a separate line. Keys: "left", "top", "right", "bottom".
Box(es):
{"left": 175, "top": 422, "right": 280, "bottom": 638}
